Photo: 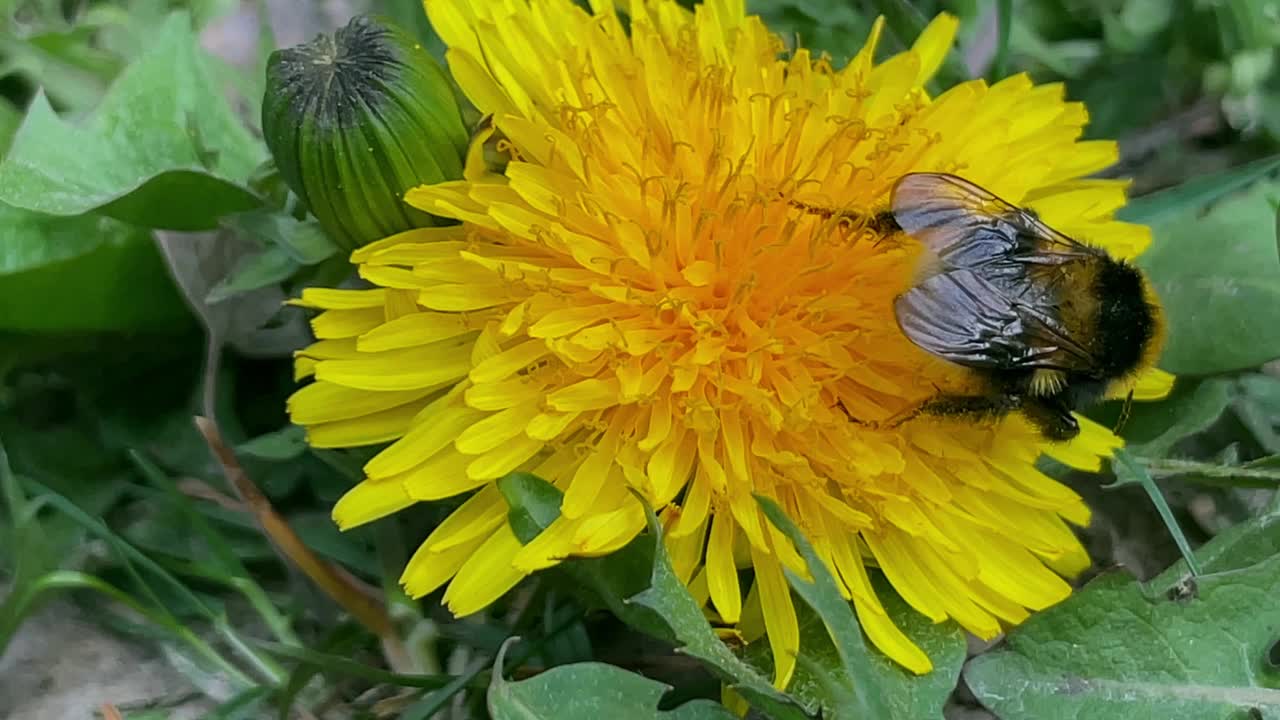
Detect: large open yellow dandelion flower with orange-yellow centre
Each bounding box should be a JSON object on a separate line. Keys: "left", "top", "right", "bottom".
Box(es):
{"left": 289, "top": 0, "right": 1170, "bottom": 685}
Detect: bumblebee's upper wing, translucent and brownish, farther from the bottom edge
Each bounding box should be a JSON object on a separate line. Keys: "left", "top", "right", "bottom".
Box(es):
{"left": 892, "top": 173, "right": 1096, "bottom": 268}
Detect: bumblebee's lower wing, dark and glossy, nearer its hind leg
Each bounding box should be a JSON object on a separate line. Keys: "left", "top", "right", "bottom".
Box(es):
{"left": 893, "top": 268, "right": 1093, "bottom": 370}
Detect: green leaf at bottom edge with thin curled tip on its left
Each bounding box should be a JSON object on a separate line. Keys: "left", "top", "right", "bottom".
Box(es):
{"left": 488, "top": 638, "right": 737, "bottom": 720}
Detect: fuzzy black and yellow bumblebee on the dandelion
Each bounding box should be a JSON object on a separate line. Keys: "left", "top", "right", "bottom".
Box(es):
{"left": 874, "top": 173, "right": 1164, "bottom": 441}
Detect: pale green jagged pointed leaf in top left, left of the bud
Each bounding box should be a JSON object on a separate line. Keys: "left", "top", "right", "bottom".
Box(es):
{"left": 0, "top": 13, "right": 265, "bottom": 229}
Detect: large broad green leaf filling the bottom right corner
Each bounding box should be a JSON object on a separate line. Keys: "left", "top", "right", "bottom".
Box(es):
{"left": 964, "top": 507, "right": 1280, "bottom": 720}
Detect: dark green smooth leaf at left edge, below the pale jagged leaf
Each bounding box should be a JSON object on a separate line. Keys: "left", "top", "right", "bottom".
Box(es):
{"left": 0, "top": 208, "right": 192, "bottom": 333}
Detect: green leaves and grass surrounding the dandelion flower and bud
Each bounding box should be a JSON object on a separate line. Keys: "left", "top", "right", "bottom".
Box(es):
{"left": 0, "top": 0, "right": 1280, "bottom": 720}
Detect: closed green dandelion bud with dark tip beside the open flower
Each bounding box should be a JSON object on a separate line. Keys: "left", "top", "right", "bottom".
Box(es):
{"left": 262, "top": 15, "right": 467, "bottom": 250}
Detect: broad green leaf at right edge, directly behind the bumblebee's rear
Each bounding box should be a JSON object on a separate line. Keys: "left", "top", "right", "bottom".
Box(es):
{"left": 1138, "top": 182, "right": 1280, "bottom": 375}
